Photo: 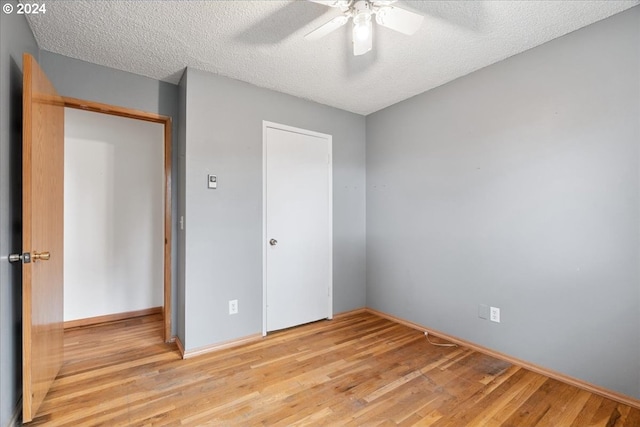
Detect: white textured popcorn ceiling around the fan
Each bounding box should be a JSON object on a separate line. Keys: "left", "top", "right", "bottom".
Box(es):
{"left": 28, "top": 0, "right": 640, "bottom": 114}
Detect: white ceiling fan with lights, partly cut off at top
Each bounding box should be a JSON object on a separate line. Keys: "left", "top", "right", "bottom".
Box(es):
{"left": 304, "top": 0, "right": 423, "bottom": 56}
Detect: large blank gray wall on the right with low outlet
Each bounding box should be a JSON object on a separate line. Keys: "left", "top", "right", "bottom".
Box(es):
{"left": 367, "top": 7, "right": 640, "bottom": 398}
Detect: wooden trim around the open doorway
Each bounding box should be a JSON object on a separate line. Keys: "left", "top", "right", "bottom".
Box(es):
{"left": 62, "top": 97, "right": 172, "bottom": 342}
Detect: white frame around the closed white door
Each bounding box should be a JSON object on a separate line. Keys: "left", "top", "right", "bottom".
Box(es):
{"left": 262, "top": 120, "right": 333, "bottom": 336}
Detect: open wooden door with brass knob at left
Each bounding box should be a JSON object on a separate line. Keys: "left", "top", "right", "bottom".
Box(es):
{"left": 22, "top": 54, "right": 64, "bottom": 422}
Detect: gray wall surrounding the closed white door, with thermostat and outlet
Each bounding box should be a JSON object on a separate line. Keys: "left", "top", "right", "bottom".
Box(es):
{"left": 181, "top": 69, "right": 365, "bottom": 349}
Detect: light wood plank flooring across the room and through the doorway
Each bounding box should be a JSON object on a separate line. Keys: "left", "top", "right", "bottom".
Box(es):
{"left": 28, "top": 313, "right": 640, "bottom": 427}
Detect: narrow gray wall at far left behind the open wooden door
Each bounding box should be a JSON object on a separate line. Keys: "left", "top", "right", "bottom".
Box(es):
{"left": 0, "top": 1, "right": 38, "bottom": 426}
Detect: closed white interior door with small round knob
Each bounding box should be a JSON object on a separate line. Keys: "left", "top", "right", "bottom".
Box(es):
{"left": 263, "top": 122, "right": 333, "bottom": 334}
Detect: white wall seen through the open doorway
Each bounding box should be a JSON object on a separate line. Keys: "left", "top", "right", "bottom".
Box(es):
{"left": 64, "top": 108, "right": 164, "bottom": 321}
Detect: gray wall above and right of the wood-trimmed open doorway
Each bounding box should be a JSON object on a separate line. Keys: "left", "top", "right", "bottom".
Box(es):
{"left": 40, "top": 50, "right": 180, "bottom": 335}
